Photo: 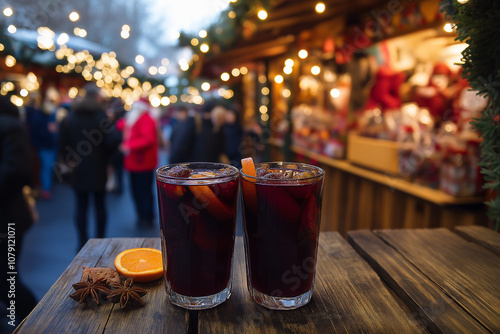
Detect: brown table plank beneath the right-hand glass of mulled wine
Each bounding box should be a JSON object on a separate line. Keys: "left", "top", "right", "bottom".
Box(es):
{"left": 198, "top": 232, "right": 420, "bottom": 333}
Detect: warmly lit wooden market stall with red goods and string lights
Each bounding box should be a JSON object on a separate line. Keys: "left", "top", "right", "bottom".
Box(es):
{"left": 195, "top": 1, "right": 487, "bottom": 232}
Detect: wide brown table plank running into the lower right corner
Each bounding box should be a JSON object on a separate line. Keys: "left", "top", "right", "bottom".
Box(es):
{"left": 375, "top": 228, "right": 500, "bottom": 332}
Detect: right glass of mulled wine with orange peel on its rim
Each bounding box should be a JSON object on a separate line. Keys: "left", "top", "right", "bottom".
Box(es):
{"left": 241, "top": 162, "right": 324, "bottom": 310}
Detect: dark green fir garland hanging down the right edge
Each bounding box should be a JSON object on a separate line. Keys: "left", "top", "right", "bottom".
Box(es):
{"left": 441, "top": 0, "right": 500, "bottom": 231}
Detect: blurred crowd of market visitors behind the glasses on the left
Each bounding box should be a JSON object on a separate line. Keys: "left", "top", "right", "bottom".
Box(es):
{"left": 0, "top": 84, "right": 263, "bottom": 328}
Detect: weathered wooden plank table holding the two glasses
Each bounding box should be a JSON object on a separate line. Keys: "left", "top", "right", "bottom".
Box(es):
{"left": 13, "top": 226, "right": 500, "bottom": 334}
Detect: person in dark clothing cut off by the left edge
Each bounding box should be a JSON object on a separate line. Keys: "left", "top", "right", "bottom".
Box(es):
{"left": 0, "top": 96, "right": 36, "bottom": 330}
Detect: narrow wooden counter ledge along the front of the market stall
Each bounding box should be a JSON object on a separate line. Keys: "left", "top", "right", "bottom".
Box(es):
{"left": 270, "top": 141, "right": 484, "bottom": 206}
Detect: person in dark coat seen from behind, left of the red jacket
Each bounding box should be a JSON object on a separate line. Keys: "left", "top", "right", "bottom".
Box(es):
{"left": 59, "top": 84, "right": 120, "bottom": 247}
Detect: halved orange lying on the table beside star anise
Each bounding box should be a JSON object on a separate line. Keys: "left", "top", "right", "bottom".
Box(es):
{"left": 115, "top": 248, "right": 163, "bottom": 282}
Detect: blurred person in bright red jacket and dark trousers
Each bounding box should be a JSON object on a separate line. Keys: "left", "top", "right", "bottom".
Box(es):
{"left": 121, "top": 98, "right": 158, "bottom": 226}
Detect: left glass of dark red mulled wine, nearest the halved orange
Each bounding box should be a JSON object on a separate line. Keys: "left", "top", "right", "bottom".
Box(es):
{"left": 156, "top": 163, "right": 239, "bottom": 310}
